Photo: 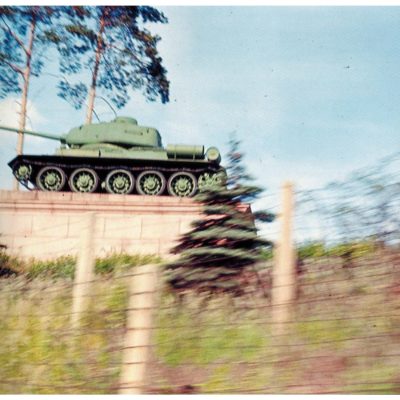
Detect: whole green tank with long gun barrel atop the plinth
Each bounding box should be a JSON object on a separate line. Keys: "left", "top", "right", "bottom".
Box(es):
{"left": 0, "top": 117, "right": 226, "bottom": 197}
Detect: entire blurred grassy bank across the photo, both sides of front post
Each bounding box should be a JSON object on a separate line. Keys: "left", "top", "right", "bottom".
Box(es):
{"left": 0, "top": 253, "right": 400, "bottom": 394}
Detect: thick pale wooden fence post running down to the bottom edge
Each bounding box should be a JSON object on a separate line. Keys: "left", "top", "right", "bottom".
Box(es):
{"left": 119, "top": 264, "right": 159, "bottom": 394}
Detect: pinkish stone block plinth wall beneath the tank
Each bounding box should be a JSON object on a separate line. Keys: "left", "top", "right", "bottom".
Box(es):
{"left": 0, "top": 191, "right": 200, "bottom": 259}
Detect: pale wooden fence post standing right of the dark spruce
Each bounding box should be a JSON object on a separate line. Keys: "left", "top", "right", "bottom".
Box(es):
{"left": 272, "top": 182, "right": 296, "bottom": 335}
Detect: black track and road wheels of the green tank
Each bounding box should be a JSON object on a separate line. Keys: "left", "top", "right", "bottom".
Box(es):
{"left": 8, "top": 155, "right": 226, "bottom": 197}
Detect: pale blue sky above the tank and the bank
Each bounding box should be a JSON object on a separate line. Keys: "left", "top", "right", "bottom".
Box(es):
{"left": 0, "top": 6, "right": 400, "bottom": 200}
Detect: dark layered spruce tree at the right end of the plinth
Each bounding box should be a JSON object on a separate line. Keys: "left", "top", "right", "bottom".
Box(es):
{"left": 165, "top": 138, "right": 273, "bottom": 295}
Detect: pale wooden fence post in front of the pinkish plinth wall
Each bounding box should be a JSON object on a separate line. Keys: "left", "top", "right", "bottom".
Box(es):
{"left": 71, "top": 212, "right": 95, "bottom": 329}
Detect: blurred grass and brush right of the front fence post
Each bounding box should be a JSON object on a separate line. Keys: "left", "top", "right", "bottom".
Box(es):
{"left": 152, "top": 250, "right": 400, "bottom": 394}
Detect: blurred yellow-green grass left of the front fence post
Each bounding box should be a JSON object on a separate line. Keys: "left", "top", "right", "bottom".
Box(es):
{"left": 0, "top": 254, "right": 158, "bottom": 394}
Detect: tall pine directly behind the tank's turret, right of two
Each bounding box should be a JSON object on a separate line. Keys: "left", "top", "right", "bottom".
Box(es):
{"left": 49, "top": 6, "right": 169, "bottom": 123}
